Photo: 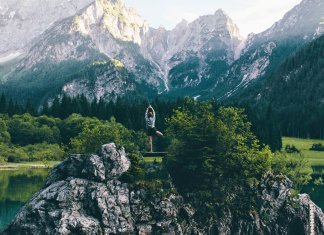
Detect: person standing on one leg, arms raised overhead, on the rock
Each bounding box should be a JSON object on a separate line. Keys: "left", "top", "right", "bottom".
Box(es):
{"left": 145, "top": 105, "right": 163, "bottom": 152}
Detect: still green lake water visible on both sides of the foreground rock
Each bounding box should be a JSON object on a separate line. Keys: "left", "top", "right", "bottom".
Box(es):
{"left": 0, "top": 167, "right": 324, "bottom": 231}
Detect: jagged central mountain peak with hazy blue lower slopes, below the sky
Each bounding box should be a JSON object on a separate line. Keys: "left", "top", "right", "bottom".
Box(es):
{"left": 141, "top": 10, "right": 243, "bottom": 88}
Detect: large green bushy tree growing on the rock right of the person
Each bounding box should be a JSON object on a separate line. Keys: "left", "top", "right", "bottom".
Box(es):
{"left": 166, "top": 99, "right": 271, "bottom": 215}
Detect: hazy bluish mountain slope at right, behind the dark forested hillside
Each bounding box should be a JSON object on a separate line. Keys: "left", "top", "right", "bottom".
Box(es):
{"left": 208, "top": 0, "right": 324, "bottom": 99}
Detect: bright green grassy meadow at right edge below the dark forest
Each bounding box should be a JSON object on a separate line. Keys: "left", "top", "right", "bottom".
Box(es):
{"left": 282, "top": 137, "right": 324, "bottom": 166}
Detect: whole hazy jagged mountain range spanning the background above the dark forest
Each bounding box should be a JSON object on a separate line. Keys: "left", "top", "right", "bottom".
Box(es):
{"left": 0, "top": 0, "right": 324, "bottom": 105}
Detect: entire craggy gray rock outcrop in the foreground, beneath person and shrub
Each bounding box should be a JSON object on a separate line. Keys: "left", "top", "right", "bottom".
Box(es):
{"left": 2, "top": 144, "right": 324, "bottom": 235}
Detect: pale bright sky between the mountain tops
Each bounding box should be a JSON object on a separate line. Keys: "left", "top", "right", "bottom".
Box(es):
{"left": 125, "top": 0, "right": 301, "bottom": 36}
